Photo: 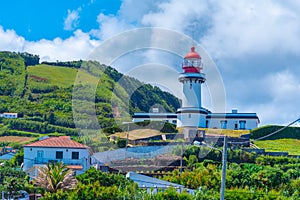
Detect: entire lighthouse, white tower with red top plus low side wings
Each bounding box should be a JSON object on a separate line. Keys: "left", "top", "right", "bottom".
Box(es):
{"left": 133, "top": 47, "right": 260, "bottom": 130}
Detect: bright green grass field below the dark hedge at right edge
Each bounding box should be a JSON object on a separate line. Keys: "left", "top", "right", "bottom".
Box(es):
{"left": 254, "top": 138, "right": 300, "bottom": 155}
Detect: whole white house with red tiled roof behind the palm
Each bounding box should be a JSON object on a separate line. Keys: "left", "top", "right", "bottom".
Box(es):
{"left": 23, "top": 136, "right": 92, "bottom": 174}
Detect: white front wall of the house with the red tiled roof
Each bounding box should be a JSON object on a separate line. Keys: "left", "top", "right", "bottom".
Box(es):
{"left": 23, "top": 147, "right": 90, "bottom": 174}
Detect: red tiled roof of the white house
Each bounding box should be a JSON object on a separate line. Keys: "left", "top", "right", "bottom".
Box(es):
{"left": 24, "top": 136, "right": 89, "bottom": 149}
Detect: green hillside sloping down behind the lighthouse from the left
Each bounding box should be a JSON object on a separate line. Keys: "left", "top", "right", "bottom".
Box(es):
{"left": 0, "top": 52, "right": 180, "bottom": 142}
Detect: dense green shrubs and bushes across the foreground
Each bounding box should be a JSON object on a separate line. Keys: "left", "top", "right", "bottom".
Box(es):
{"left": 0, "top": 151, "right": 300, "bottom": 200}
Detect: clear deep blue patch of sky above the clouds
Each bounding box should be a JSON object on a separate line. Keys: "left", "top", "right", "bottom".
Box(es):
{"left": 0, "top": 0, "right": 121, "bottom": 41}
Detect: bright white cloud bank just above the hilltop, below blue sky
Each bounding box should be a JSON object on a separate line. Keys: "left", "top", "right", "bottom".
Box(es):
{"left": 0, "top": 26, "right": 100, "bottom": 61}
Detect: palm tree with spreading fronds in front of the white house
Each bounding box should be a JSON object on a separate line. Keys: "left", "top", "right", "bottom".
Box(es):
{"left": 34, "top": 162, "right": 77, "bottom": 193}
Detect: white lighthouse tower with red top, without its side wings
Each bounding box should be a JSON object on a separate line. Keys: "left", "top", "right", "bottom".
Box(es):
{"left": 177, "top": 47, "right": 208, "bottom": 128}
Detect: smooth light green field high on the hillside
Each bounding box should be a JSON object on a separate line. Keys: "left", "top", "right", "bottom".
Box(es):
{"left": 27, "top": 64, "right": 98, "bottom": 88}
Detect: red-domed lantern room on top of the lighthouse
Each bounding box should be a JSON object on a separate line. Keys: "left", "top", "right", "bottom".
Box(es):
{"left": 182, "top": 47, "right": 202, "bottom": 73}
